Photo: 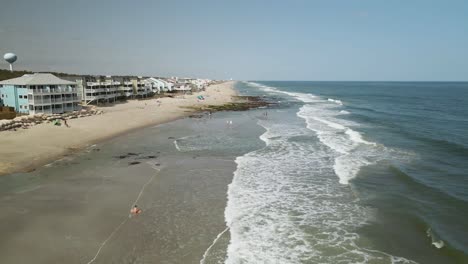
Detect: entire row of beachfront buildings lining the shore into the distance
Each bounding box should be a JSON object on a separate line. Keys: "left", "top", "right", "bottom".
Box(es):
{"left": 0, "top": 73, "right": 216, "bottom": 114}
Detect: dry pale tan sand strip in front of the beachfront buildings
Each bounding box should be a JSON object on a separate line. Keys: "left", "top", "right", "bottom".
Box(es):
{"left": 0, "top": 82, "right": 236, "bottom": 175}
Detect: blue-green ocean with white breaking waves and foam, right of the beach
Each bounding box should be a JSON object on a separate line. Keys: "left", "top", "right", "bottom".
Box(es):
{"left": 225, "top": 81, "right": 468, "bottom": 263}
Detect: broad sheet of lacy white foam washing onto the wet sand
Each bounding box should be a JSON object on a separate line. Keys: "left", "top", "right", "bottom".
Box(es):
{"left": 225, "top": 116, "right": 414, "bottom": 264}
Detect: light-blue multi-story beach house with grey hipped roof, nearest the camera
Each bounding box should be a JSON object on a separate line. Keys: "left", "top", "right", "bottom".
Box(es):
{"left": 0, "top": 73, "right": 81, "bottom": 114}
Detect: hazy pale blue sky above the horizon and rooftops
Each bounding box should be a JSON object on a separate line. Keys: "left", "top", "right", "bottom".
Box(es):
{"left": 0, "top": 0, "right": 468, "bottom": 81}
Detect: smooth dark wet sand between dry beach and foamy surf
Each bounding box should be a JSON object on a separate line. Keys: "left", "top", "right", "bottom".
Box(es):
{"left": 0, "top": 108, "right": 266, "bottom": 263}
